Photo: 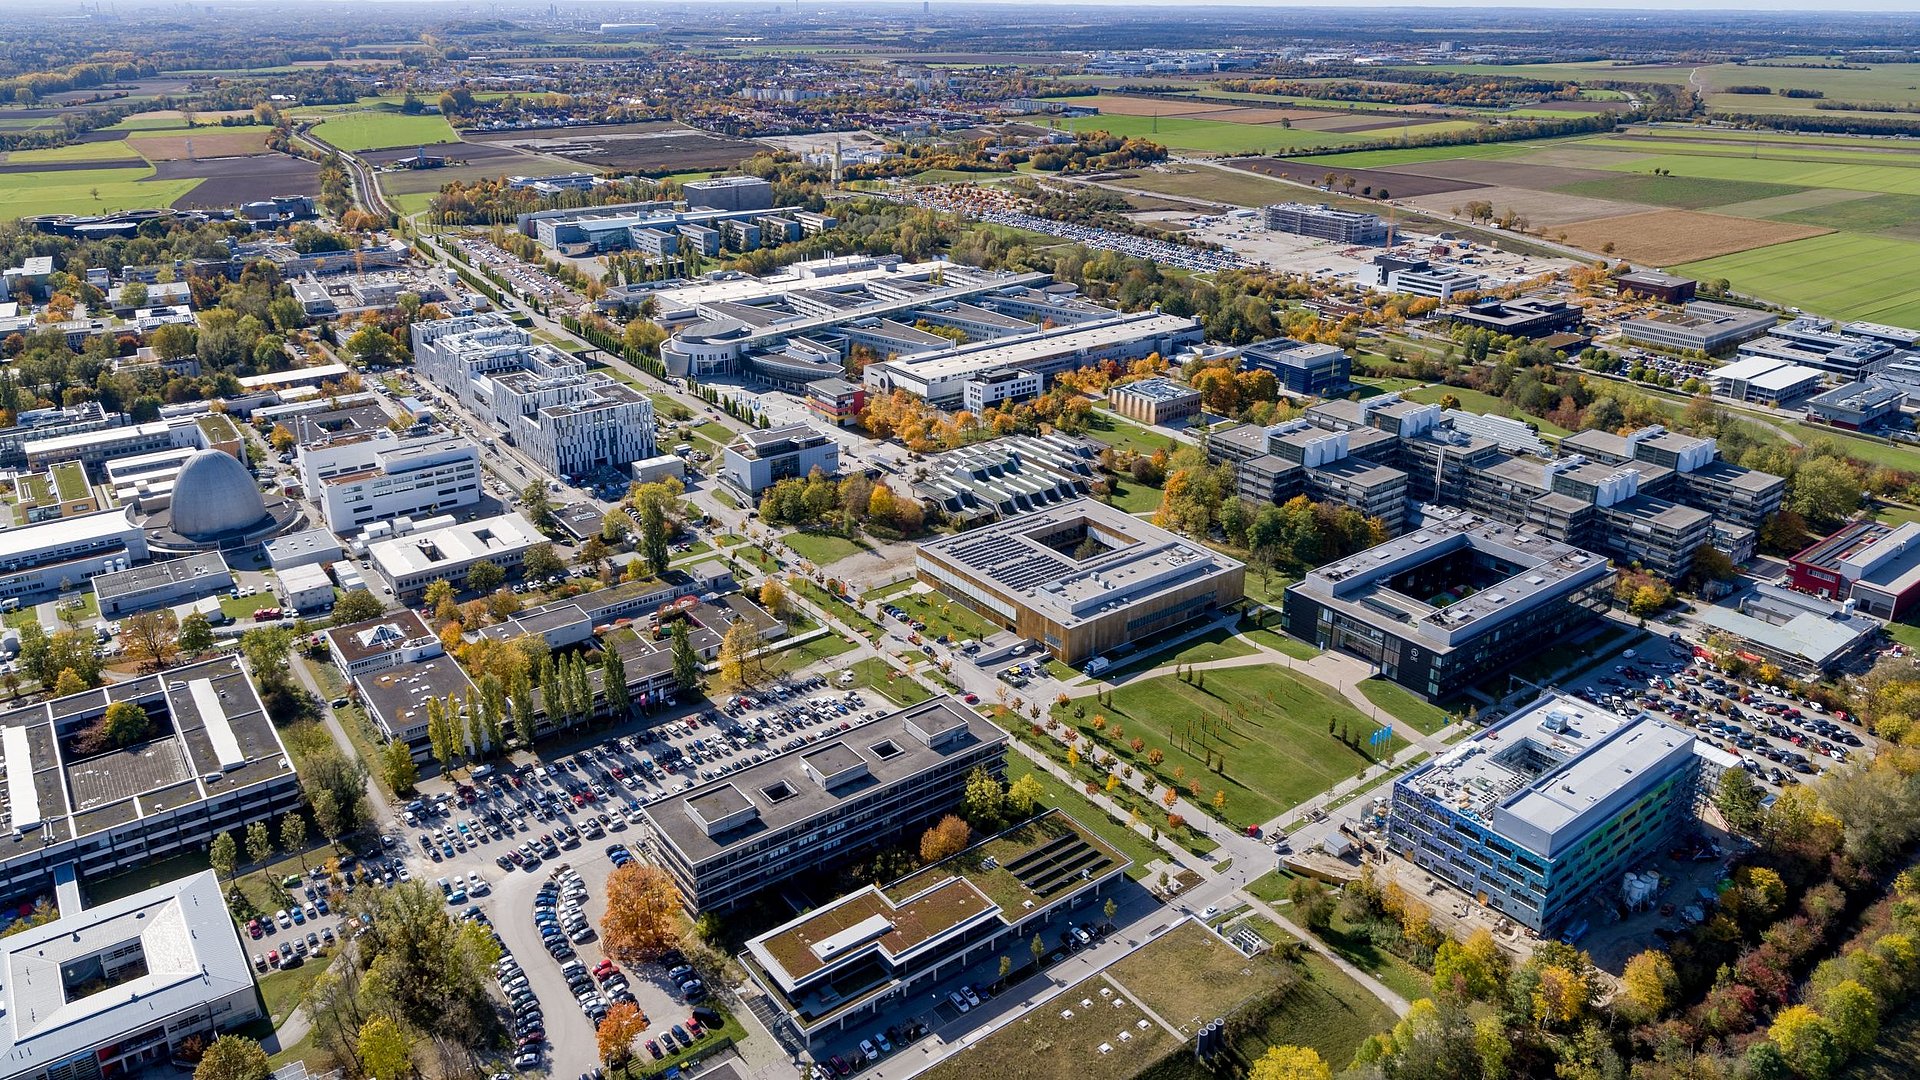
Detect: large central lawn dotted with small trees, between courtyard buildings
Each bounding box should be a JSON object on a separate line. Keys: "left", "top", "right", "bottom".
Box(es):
{"left": 1054, "top": 661, "right": 1373, "bottom": 822}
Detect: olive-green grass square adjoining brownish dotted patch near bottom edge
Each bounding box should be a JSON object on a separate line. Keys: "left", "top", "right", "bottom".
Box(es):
{"left": 1106, "top": 922, "right": 1286, "bottom": 1034}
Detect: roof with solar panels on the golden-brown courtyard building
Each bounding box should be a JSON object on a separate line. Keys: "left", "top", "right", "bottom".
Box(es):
{"left": 922, "top": 498, "right": 1242, "bottom": 626}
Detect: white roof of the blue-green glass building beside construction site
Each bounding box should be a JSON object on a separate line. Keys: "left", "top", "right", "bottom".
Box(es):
{"left": 1398, "top": 692, "right": 1693, "bottom": 859}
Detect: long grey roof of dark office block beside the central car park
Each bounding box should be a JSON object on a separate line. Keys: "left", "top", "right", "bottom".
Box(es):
{"left": 641, "top": 698, "right": 1006, "bottom": 867}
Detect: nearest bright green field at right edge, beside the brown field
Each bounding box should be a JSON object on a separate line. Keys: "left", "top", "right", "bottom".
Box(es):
{"left": 1674, "top": 233, "right": 1920, "bottom": 327}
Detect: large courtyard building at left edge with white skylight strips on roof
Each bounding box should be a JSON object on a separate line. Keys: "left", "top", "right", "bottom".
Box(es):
{"left": 0, "top": 657, "right": 303, "bottom": 899}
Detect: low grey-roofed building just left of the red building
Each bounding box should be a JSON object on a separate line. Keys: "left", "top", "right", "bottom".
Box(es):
{"left": 1695, "top": 584, "right": 1873, "bottom": 682}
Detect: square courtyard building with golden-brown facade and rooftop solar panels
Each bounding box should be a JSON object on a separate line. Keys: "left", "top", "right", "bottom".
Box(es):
{"left": 914, "top": 500, "right": 1246, "bottom": 663}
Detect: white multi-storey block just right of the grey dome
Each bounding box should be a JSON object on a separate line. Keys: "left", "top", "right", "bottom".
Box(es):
{"left": 298, "top": 430, "right": 482, "bottom": 532}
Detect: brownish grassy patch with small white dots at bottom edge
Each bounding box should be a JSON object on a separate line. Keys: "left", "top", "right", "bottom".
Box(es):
{"left": 922, "top": 957, "right": 1179, "bottom": 1080}
